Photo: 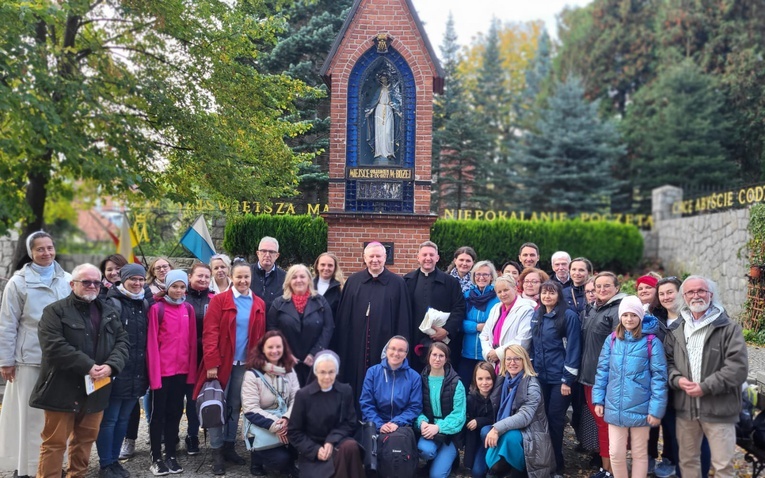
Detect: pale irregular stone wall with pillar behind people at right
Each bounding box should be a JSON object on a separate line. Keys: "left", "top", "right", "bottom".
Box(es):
{"left": 654, "top": 187, "right": 749, "bottom": 317}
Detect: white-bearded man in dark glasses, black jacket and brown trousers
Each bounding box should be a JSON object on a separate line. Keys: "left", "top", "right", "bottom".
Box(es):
{"left": 29, "top": 264, "right": 129, "bottom": 478}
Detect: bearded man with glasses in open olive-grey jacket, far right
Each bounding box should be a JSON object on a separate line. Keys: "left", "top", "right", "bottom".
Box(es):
{"left": 666, "top": 276, "right": 749, "bottom": 478}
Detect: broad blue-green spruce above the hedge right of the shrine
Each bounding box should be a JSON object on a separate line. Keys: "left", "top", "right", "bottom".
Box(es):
{"left": 515, "top": 77, "right": 625, "bottom": 213}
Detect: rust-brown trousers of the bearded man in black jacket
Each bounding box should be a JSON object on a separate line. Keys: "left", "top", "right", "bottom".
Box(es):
{"left": 37, "top": 410, "right": 103, "bottom": 478}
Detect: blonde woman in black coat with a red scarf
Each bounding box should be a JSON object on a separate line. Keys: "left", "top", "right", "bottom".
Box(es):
{"left": 266, "top": 264, "right": 335, "bottom": 387}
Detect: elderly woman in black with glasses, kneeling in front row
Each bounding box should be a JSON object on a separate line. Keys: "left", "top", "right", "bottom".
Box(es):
{"left": 287, "top": 350, "right": 365, "bottom": 478}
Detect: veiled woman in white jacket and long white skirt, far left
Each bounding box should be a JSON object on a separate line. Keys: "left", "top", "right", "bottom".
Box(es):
{"left": 0, "top": 231, "right": 72, "bottom": 478}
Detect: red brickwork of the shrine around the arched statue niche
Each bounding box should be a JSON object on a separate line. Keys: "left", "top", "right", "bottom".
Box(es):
{"left": 324, "top": 0, "right": 436, "bottom": 273}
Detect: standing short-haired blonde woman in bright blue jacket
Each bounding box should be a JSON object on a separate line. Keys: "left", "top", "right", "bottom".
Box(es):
{"left": 457, "top": 261, "right": 499, "bottom": 387}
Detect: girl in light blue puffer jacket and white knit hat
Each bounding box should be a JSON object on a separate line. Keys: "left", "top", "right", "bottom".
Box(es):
{"left": 592, "top": 296, "right": 667, "bottom": 478}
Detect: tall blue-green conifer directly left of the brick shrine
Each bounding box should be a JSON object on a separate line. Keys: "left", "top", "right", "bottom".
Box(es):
{"left": 259, "top": 0, "right": 353, "bottom": 203}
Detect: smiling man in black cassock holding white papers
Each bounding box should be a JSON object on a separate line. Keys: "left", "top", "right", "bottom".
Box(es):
{"left": 404, "top": 241, "right": 465, "bottom": 372}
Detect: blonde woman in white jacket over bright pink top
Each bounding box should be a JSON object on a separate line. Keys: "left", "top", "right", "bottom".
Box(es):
{"left": 479, "top": 275, "right": 536, "bottom": 367}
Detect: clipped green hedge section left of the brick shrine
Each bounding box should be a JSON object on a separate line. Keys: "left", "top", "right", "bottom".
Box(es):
{"left": 223, "top": 214, "right": 327, "bottom": 268}
